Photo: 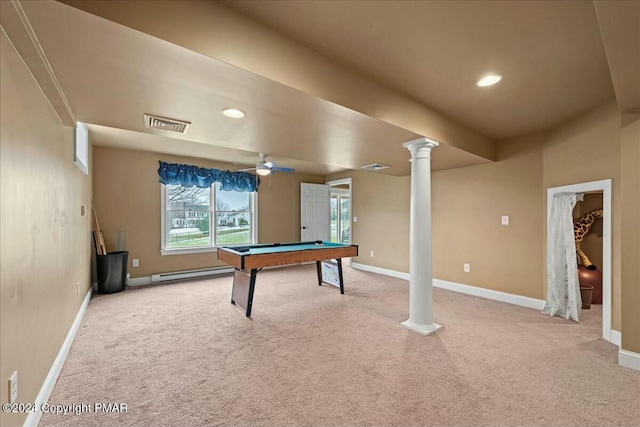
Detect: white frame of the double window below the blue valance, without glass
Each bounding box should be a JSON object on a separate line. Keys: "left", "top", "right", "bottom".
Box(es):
{"left": 160, "top": 184, "right": 258, "bottom": 256}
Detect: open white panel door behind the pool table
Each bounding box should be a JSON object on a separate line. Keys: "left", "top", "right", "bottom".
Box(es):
{"left": 300, "top": 183, "right": 330, "bottom": 242}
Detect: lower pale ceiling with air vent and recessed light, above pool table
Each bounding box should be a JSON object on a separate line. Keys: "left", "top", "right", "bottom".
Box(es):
{"left": 15, "top": 2, "right": 468, "bottom": 175}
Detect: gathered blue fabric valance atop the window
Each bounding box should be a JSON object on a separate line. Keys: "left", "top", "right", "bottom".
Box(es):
{"left": 158, "top": 161, "right": 260, "bottom": 192}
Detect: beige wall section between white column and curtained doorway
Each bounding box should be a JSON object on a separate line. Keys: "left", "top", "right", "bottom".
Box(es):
{"left": 432, "top": 135, "right": 544, "bottom": 298}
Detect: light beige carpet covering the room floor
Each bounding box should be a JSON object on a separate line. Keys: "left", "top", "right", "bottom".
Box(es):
{"left": 40, "top": 265, "right": 640, "bottom": 426}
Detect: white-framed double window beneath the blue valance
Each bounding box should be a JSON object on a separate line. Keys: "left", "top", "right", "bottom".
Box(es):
{"left": 161, "top": 183, "right": 257, "bottom": 255}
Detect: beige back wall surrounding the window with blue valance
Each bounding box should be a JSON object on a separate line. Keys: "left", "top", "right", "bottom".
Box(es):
{"left": 93, "top": 147, "right": 324, "bottom": 278}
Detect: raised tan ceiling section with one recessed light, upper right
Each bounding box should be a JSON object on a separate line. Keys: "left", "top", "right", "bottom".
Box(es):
{"left": 224, "top": 0, "right": 614, "bottom": 139}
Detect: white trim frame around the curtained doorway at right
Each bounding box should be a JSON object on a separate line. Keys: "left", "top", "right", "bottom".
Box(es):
{"left": 545, "top": 179, "right": 620, "bottom": 346}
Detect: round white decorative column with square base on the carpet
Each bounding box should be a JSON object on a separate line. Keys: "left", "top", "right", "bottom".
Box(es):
{"left": 402, "top": 138, "right": 442, "bottom": 335}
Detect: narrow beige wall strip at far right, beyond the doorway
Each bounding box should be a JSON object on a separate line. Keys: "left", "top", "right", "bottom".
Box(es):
{"left": 620, "top": 118, "right": 640, "bottom": 354}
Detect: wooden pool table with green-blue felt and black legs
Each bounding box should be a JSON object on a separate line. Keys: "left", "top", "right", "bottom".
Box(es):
{"left": 218, "top": 241, "right": 358, "bottom": 317}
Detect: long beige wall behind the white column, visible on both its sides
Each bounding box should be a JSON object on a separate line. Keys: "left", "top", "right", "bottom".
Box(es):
{"left": 328, "top": 136, "right": 543, "bottom": 298}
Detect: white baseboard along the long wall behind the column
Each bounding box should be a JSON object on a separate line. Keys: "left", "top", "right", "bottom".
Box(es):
{"left": 351, "top": 262, "right": 545, "bottom": 310}
